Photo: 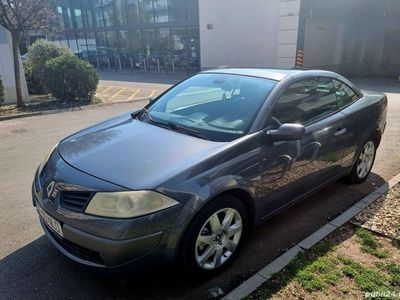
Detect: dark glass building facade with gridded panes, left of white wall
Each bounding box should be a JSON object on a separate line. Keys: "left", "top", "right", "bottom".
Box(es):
{"left": 48, "top": 0, "right": 200, "bottom": 71}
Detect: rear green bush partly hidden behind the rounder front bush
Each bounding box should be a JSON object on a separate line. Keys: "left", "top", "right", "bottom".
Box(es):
{"left": 28, "top": 39, "right": 73, "bottom": 86}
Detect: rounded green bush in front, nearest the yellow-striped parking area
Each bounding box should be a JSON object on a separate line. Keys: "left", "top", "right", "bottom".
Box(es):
{"left": 44, "top": 54, "right": 99, "bottom": 101}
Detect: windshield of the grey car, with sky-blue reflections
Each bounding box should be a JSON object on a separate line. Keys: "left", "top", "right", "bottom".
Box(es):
{"left": 141, "top": 73, "right": 276, "bottom": 141}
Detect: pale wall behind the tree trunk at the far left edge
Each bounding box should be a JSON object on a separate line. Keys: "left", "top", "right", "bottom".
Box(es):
{"left": 0, "top": 26, "right": 29, "bottom": 103}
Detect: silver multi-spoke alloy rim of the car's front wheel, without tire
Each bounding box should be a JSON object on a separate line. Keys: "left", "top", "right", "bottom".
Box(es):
{"left": 195, "top": 208, "right": 243, "bottom": 270}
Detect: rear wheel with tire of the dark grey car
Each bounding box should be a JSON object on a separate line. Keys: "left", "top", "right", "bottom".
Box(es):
{"left": 346, "top": 138, "right": 377, "bottom": 184}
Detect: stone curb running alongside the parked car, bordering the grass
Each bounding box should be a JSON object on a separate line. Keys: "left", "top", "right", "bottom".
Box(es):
{"left": 222, "top": 173, "right": 400, "bottom": 300}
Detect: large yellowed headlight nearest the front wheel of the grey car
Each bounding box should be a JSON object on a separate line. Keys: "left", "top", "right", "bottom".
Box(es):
{"left": 85, "top": 191, "right": 179, "bottom": 218}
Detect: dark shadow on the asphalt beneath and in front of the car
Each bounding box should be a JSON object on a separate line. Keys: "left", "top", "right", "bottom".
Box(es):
{"left": 0, "top": 173, "right": 385, "bottom": 299}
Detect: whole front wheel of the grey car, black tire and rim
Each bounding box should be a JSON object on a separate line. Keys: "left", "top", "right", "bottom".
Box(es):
{"left": 180, "top": 195, "right": 248, "bottom": 276}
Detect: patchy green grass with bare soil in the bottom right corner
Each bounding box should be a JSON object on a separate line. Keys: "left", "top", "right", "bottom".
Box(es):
{"left": 247, "top": 229, "right": 400, "bottom": 299}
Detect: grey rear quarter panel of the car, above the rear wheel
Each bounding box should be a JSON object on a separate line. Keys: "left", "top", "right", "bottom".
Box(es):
{"left": 342, "top": 91, "right": 387, "bottom": 167}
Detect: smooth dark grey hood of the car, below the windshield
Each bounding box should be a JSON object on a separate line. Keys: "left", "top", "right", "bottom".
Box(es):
{"left": 57, "top": 114, "right": 226, "bottom": 189}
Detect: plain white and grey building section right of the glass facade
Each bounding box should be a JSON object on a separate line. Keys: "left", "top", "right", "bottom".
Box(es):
{"left": 199, "top": 0, "right": 400, "bottom": 76}
